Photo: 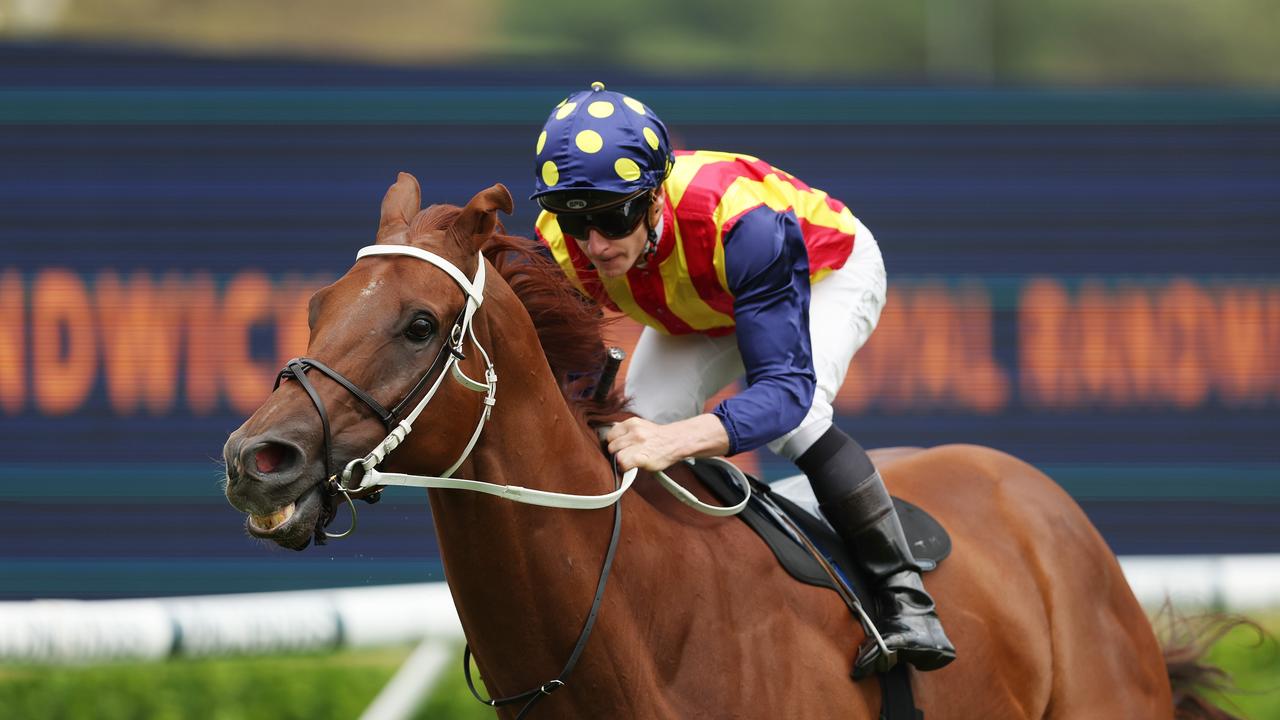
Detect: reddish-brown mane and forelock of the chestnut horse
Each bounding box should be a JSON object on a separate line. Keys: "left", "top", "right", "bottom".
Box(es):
{"left": 408, "top": 205, "right": 628, "bottom": 424}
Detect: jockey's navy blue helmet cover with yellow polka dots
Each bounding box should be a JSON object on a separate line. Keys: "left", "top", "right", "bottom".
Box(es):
{"left": 531, "top": 82, "right": 673, "bottom": 210}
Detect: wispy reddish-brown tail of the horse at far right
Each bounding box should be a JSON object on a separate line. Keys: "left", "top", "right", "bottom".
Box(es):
{"left": 1160, "top": 603, "right": 1266, "bottom": 720}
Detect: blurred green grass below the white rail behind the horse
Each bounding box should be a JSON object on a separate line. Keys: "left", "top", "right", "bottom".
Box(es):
{"left": 0, "top": 611, "right": 1280, "bottom": 720}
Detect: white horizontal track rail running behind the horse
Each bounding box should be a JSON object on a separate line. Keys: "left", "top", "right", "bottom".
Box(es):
{"left": 0, "top": 555, "right": 1280, "bottom": 664}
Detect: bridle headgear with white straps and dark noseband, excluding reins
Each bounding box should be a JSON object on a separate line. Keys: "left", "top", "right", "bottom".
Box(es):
{"left": 271, "top": 245, "right": 498, "bottom": 544}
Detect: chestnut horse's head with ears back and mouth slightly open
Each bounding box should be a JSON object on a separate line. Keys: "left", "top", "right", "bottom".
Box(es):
{"left": 223, "top": 173, "right": 512, "bottom": 550}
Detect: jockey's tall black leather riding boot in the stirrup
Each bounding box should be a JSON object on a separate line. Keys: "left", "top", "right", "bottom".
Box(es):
{"left": 796, "top": 427, "right": 956, "bottom": 679}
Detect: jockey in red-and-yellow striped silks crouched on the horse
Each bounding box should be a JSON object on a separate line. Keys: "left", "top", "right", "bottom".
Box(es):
{"left": 534, "top": 82, "right": 955, "bottom": 678}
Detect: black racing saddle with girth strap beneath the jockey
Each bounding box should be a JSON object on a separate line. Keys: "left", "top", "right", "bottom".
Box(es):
{"left": 691, "top": 461, "right": 951, "bottom": 720}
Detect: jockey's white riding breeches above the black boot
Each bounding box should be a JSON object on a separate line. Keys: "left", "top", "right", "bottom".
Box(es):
{"left": 626, "top": 215, "right": 886, "bottom": 460}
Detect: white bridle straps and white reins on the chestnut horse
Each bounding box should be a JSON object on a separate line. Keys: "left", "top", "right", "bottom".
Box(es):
{"left": 334, "top": 245, "right": 750, "bottom": 520}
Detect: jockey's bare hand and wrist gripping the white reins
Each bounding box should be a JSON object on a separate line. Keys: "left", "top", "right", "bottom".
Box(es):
{"left": 604, "top": 415, "right": 728, "bottom": 471}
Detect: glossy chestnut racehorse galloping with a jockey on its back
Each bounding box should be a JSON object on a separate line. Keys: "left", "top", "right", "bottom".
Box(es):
{"left": 224, "top": 173, "right": 1233, "bottom": 720}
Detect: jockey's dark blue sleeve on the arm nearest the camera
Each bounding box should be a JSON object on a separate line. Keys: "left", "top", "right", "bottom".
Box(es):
{"left": 713, "top": 206, "right": 817, "bottom": 455}
